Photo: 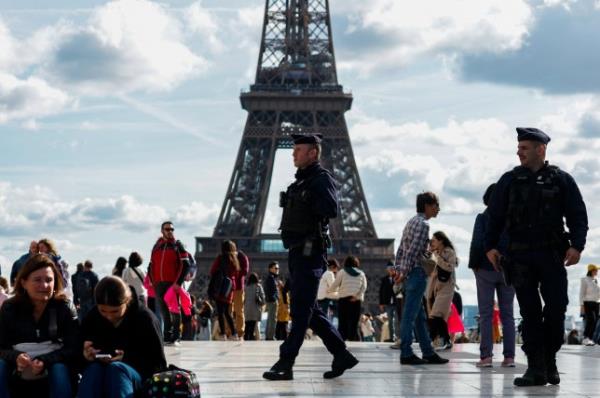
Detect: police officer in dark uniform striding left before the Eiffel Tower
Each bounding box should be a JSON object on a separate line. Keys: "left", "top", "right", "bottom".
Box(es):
{"left": 263, "top": 134, "right": 358, "bottom": 380}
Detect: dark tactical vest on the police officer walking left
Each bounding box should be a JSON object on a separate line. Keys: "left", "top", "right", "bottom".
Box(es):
{"left": 279, "top": 169, "right": 327, "bottom": 243}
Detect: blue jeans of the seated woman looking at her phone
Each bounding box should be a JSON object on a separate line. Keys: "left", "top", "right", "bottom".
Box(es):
{"left": 79, "top": 362, "right": 142, "bottom": 398}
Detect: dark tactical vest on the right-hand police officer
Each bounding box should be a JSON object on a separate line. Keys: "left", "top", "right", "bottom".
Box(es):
{"left": 506, "top": 165, "right": 564, "bottom": 245}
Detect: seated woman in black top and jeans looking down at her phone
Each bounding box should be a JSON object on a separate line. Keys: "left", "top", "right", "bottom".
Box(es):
{"left": 79, "top": 276, "right": 166, "bottom": 398}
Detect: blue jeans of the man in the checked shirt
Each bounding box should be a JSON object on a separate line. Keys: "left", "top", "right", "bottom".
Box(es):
{"left": 400, "top": 267, "right": 434, "bottom": 358}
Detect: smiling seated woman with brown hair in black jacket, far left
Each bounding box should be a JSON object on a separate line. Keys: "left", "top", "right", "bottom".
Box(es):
{"left": 0, "top": 254, "right": 78, "bottom": 398}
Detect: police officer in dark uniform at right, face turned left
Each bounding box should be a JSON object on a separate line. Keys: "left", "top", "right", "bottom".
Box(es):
{"left": 486, "top": 127, "right": 588, "bottom": 386}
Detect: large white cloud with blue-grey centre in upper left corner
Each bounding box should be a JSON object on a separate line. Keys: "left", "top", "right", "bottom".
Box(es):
{"left": 0, "top": 0, "right": 218, "bottom": 122}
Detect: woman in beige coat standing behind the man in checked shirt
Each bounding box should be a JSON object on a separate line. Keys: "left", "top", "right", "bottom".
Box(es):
{"left": 427, "top": 231, "right": 458, "bottom": 349}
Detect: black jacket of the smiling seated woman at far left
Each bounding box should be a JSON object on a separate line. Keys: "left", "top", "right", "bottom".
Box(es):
{"left": 0, "top": 297, "right": 80, "bottom": 368}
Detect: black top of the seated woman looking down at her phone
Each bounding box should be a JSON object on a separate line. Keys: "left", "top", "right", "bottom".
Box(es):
{"left": 81, "top": 300, "right": 166, "bottom": 379}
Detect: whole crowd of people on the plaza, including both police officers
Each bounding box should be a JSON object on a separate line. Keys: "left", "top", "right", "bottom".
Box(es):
{"left": 0, "top": 128, "right": 600, "bottom": 392}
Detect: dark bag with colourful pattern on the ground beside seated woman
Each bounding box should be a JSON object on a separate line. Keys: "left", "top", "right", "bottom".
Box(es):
{"left": 140, "top": 365, "right": 200, "bottom": 398}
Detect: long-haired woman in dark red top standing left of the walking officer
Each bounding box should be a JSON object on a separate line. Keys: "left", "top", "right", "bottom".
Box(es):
{"left": 210, "top": 240, "right": 241, "bottom": 340}
